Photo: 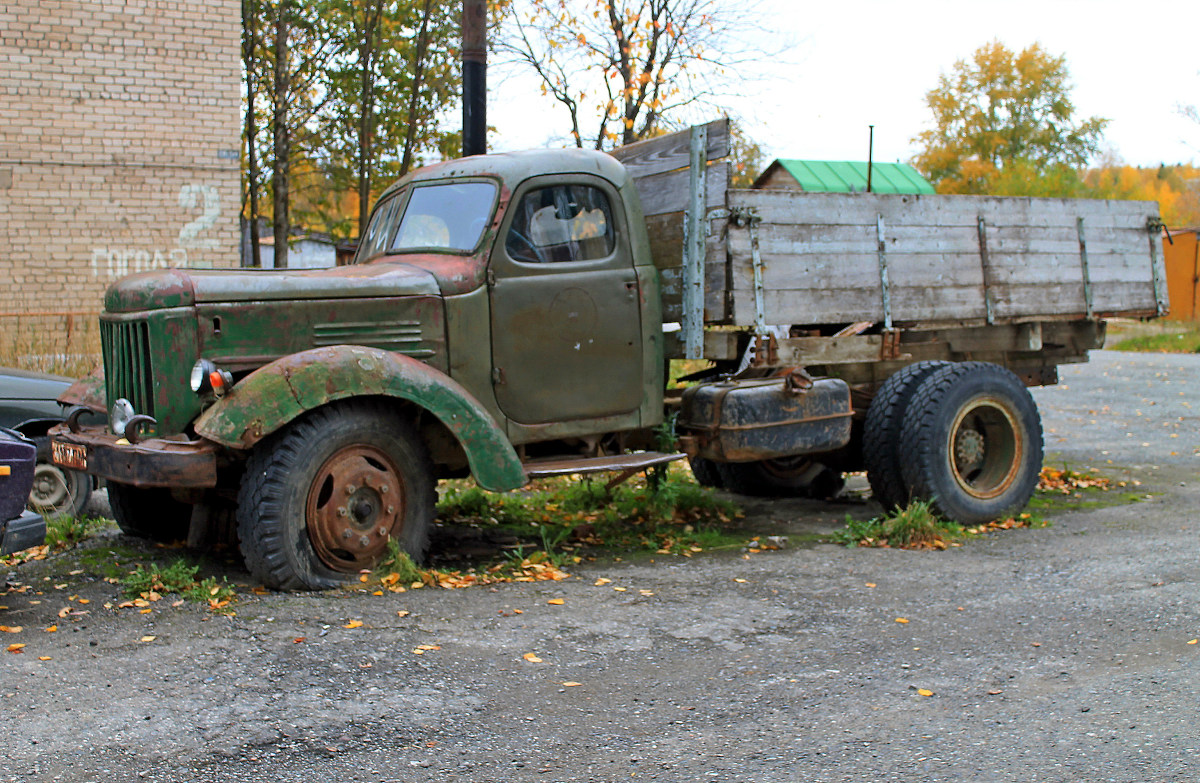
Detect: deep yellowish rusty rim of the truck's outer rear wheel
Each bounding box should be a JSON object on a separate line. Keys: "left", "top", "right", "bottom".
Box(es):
{"left": 946, "top": 396, "right": 1026, "bottom": 500}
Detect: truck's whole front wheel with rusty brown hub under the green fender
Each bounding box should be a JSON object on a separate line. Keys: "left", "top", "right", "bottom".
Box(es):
{"left": 238, "top": 401, "right": 434, "bottom": 590}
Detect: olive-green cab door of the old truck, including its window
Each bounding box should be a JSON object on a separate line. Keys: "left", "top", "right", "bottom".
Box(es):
{"left": 491, "top": 175, "right": 643, "bottom": 424}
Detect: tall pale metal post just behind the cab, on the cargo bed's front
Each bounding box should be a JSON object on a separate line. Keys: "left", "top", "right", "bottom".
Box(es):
{"left": 683, "top": 125, "right": 708, "bottom": 359}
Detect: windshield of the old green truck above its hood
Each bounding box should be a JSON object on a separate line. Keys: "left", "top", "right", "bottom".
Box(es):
{"left": 358, "top": 177, "right": 496, "bottom": 262}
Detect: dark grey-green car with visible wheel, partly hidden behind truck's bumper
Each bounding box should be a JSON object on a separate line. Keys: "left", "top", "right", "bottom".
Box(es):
{"left": 0, "top": 367, "right": 92, "bottom": 516}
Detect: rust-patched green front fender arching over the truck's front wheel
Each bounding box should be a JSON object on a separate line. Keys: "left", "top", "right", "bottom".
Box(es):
{"left": 196, "top": 346, "right": 528, "bottom": 491}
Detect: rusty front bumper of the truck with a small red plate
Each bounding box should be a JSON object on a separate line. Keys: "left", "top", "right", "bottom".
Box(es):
{"left": 50, "top": 424, "right": 221, "bottom": 489}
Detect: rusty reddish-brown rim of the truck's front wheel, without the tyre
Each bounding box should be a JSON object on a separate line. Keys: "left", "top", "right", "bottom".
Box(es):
{"left": 305, "top": 444, "right": 404, "bottom": 573}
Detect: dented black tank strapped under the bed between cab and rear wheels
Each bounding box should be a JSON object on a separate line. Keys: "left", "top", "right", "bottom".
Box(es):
{"left": 677, "top": 376, "right": 853, "bottom": 462}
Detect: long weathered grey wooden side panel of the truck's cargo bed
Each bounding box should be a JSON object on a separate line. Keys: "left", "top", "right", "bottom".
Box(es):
{"left": 722, "top": 191, "right": 1158, "bottom": 325}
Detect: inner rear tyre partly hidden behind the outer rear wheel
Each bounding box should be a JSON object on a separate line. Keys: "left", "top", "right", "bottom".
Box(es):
{"left": 863, "top": 361, "right": 950, "bottom": 512}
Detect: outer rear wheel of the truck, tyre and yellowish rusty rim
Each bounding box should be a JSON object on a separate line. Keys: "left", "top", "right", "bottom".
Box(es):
{"left": 900, "top": 361, "right": 1042, "bottom": 525}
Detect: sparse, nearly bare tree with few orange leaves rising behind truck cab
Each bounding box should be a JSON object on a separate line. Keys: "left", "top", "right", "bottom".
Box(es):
{"left": 493, "top": 0, "right": 750, "bottom": 149}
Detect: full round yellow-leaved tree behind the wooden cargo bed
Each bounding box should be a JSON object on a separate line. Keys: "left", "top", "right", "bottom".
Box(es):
{"left": 912, "top": 41, "right": 1108, "bottom": 196}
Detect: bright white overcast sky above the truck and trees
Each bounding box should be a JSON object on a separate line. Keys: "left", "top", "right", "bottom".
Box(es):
{"left": 488, "top": 0, "right": 1200, "bottom": 166}
